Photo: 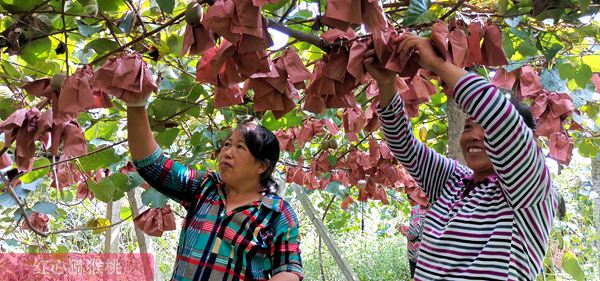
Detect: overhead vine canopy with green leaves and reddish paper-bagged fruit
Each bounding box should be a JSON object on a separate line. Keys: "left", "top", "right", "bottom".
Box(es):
{"left": 0, "top": 0, "right": 600, "bottom": 272}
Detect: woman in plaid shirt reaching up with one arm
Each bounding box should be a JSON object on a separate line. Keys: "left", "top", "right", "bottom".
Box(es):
{"left": 127, "top": 103, "right": 303, "bottom": 281}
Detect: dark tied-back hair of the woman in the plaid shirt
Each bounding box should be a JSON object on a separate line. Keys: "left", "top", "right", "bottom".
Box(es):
{"left": 236, "top": 120, "right": 279, "bottom": 194}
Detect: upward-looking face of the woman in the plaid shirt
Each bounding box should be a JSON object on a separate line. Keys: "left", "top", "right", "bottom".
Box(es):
{"left": 218, "top": 130, "right": 266, "bottom": 187}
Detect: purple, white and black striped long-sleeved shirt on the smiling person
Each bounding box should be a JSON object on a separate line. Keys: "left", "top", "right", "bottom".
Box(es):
{"left": 378, "top": 74, "right": 557, "bottom": 280}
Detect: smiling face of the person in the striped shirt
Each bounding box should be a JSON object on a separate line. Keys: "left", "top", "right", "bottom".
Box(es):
{"left": 460, "top": 118, "right": 495, "bottom": 177}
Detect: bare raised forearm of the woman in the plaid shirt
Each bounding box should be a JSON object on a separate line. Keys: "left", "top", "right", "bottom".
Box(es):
{"left": 127, "top": 107, "right": 158, "bottom": 160}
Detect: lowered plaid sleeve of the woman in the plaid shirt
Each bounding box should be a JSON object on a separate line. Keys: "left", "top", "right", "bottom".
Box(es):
{"left": 272, "top": 201, "right": 304, "bottom": 280}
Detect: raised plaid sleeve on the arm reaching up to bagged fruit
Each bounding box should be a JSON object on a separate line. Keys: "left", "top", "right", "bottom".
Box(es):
{"left": 133, "top": 148, "right": 205, "bottom": 206}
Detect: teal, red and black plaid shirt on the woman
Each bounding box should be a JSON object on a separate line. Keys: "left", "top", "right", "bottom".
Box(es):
{"left": 134, "top": 149, "right": 303, "bottom": 281}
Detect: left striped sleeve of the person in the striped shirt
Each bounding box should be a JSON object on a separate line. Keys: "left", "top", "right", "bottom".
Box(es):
{"left": 378, "top": 94, "right": 468, "bottom": 204}
